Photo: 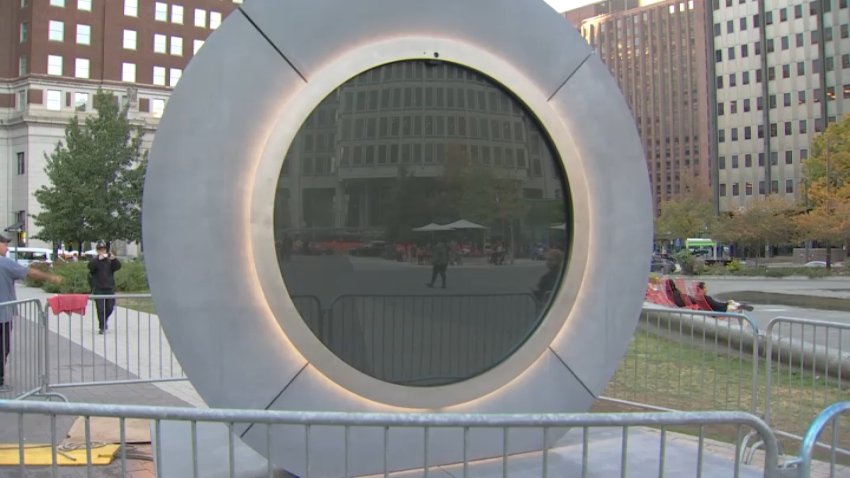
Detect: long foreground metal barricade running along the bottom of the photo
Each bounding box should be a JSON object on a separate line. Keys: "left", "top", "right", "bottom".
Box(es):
{"left": 0, "top": 401, "right": 781, "bottom": 477}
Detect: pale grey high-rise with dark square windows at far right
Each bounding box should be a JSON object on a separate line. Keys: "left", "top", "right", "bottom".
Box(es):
{"left": 712, "top": 0, "right": 850, "bottom": 211}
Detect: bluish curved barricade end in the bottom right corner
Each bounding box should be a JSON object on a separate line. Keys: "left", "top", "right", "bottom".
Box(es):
{"left": 789, "top": 402, "right": 850, "bottom": 478}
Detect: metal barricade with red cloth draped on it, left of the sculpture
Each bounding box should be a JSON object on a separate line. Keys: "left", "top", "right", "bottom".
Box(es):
{"left": 44, "top": 294, "right": 186, "bottom": 389}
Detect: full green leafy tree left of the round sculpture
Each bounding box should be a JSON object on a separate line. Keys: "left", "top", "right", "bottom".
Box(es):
{"left": 33, "top": 90, "right": 147, "bottom": 248}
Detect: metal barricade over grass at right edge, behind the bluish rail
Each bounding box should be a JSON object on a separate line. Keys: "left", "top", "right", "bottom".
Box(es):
{"left": 764, "top": 317, "right": 850, "bottom": 448}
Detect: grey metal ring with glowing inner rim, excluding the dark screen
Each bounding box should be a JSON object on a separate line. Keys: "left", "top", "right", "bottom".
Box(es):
{"left": 143, "top": 0, "right": 652, "bottom": 475}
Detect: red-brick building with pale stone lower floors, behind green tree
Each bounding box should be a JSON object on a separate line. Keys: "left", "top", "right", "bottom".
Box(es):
{"left": 0, "top": 0, "right": 242, "bottom": 244}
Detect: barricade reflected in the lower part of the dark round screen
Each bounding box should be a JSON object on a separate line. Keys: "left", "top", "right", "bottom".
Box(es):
{"left": 324, "top": 294, "right": 540, "bottom": 385}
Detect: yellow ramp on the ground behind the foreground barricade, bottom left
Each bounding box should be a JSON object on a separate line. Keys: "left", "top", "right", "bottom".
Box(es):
{"left": 0, "top": 444, "right": 121, "bottom": 466}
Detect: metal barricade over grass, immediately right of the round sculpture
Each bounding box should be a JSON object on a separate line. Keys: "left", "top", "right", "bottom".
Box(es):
{"left": 601, "top": 307, "right": 759, "bottom": 413}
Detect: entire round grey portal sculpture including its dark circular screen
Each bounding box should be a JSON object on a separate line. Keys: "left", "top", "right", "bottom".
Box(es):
{"left": 143, "top": 0, "right": 652, "bottom": 475}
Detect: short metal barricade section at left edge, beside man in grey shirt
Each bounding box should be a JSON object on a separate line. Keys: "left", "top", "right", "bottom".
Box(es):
{"left": 0, "top": 299, "right": 44, "bottom": 399}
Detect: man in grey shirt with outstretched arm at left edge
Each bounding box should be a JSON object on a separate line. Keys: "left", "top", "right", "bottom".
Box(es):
{"left": 0, "top": 234, "right": 62, "bottom": 393}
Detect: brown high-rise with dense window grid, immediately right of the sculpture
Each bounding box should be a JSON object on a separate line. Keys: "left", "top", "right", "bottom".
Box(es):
{"left": 565, "top": 0, "right": 713, "bottom": 210}
